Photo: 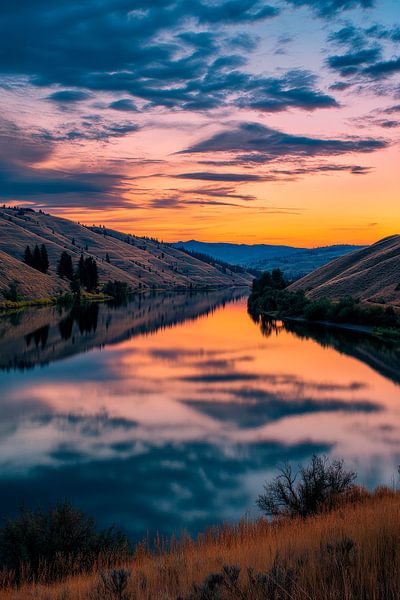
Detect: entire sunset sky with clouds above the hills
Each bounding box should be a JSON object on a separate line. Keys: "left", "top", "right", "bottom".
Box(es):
{"left": 0, "top": 0, "right": 400, "bottom": 247}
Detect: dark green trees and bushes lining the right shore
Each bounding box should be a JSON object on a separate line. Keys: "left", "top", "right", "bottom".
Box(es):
{"left": 248, "top": 269, "right": 400, "bottom": 342}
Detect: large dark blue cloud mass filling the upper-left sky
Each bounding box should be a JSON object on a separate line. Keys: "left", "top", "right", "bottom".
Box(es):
{"left": 0, "top": 0, "right": 336, "bottom": 111}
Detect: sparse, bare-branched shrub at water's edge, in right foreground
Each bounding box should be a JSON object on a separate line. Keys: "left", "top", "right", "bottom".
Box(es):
{"left": 257, "top": 455, "right": 357, "bottom": 517}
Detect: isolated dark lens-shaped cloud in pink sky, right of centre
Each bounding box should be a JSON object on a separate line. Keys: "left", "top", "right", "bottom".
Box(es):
{"left": 182, "top": 123, "right": 387, "bottom": 162}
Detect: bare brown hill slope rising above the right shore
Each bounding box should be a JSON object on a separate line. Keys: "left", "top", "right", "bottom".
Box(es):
{"left": 289, "top": 235, "right": 400, "bottom": 305}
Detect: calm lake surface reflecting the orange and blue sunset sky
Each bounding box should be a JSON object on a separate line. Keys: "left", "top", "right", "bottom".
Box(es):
{"left": 0, "top": 292, "right": 400, "bottom": 539}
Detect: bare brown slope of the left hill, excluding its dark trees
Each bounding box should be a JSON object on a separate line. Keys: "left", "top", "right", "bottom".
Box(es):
{"left": 0, "top": 207, "right": 252, "bottom": 298}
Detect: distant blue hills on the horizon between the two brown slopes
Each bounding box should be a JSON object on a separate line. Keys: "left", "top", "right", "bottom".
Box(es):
{"left": 174, "top": 240, "right": 361, "bottom": 279}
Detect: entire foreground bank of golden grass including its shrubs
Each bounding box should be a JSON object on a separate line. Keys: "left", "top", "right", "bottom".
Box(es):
{"left": 0, "top": 456, "right": 400, "bottom": 600}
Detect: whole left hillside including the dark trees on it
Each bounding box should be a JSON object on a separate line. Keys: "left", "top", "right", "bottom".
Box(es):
{"left": 0, "top": 205, "right": 252, "bottom": 308}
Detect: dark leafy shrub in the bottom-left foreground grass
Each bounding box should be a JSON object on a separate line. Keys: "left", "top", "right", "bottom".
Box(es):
{"left": 0, "top": 502, "right": 129, "bottom": 584}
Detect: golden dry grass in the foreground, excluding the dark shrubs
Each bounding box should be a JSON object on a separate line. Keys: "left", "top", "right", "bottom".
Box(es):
{"left": 0, "top": 490, "right": 400, "bottom": 600}
